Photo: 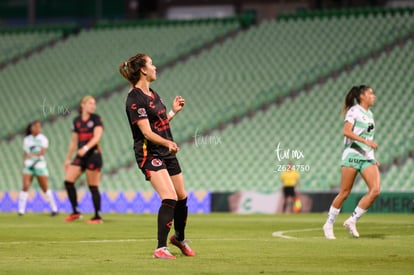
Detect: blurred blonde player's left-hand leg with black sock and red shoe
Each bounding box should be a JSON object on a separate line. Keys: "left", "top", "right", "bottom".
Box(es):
{"left": 65, "top": 165, "right": 82, "bottom": 222}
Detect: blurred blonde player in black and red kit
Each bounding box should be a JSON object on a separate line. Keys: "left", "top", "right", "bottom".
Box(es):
{"left": 64, "top": 96, "right": 103, "bottom": 223}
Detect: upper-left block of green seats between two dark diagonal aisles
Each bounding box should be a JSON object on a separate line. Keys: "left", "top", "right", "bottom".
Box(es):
{"left": 0, "top": 17, "right": 239, "bottom": 138}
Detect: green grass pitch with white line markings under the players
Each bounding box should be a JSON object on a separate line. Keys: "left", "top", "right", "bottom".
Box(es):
{"left": 0, "top": 213, "right": 414, "bottom": 274}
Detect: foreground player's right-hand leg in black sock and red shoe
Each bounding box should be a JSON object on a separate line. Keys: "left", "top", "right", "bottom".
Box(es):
{"left": 170, "top": 173, "right": 195, "bottom": 256}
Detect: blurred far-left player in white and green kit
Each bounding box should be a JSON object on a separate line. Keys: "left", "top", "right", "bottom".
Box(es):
{"left": 18, "top": 120, "right": 58, "bottom": 216}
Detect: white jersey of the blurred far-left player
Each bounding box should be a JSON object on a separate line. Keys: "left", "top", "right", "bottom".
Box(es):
{"left": 23, "top": 134, "right": 49, "bottom": 168}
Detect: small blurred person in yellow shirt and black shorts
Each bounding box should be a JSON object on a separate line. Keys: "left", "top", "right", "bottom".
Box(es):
{"left": 280, "top": 162, "right": 300, "bottom": 213}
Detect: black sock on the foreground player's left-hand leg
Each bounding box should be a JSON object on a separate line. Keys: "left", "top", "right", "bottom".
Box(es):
{"left": 157, "top": 199, "right": 177, "bottom": 248}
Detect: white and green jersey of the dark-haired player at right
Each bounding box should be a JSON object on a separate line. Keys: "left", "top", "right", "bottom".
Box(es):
{"left": 342, "top": 104, "right": 375, "bottom": 160}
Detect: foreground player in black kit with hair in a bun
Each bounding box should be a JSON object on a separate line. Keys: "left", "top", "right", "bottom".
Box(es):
{"left": 119, "top": 54, "right": 195, "bottom": 259}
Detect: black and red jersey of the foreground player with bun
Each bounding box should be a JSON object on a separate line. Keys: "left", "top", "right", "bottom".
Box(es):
{"left": 126, "top": 88, "right": 173, "bottom": 159}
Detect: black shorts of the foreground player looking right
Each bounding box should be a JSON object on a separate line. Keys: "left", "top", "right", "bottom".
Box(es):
{"left": 137, "top": 156, "right": 181, "bottom": 180}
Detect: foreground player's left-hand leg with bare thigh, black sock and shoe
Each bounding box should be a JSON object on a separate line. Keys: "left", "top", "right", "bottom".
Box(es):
{"left": 152, "top": 169, "right": 177, "bottom": 259}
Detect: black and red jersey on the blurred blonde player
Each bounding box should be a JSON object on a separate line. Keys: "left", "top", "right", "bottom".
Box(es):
{"left": 72, "top": 114, "right": 103, "bottom": 151}
